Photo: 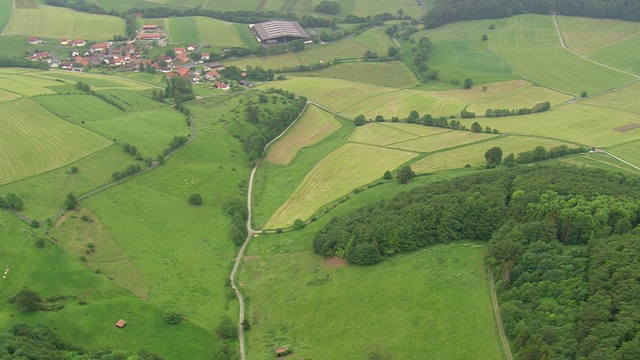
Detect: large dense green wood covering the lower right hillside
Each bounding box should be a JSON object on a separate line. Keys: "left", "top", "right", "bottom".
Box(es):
{"left": 313, "top": 165, "right": 640, "bottom": 360}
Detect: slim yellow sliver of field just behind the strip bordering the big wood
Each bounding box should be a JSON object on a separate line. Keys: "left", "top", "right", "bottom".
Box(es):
{"left": 388, "top": 131, "right": 498, "bottom": 152}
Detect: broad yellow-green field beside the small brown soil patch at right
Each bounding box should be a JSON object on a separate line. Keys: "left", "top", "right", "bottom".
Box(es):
{"left": 462, "top": 104, "right": 640, "bottom": 147}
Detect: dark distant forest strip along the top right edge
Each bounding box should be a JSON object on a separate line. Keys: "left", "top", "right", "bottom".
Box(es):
{"left": 423, "top": 0, "right": 640, "bottom": 28}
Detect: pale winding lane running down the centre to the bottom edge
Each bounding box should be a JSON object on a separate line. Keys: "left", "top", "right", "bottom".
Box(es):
{"left": 229, "top": 101, "right": 310, "bottom": 360}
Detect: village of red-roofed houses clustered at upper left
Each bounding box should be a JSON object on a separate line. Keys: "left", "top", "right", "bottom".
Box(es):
{"left": 27, "top": 25, "right": 240, "bottom": 90}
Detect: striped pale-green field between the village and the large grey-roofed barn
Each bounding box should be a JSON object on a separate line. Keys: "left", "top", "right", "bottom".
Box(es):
{"left": 166, "top": 16, "right": 256, "bottom": 47}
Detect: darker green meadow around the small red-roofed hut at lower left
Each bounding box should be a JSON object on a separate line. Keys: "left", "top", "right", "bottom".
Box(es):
{"left": 0, "top": 211, "right": 216, "bottom": 359}
